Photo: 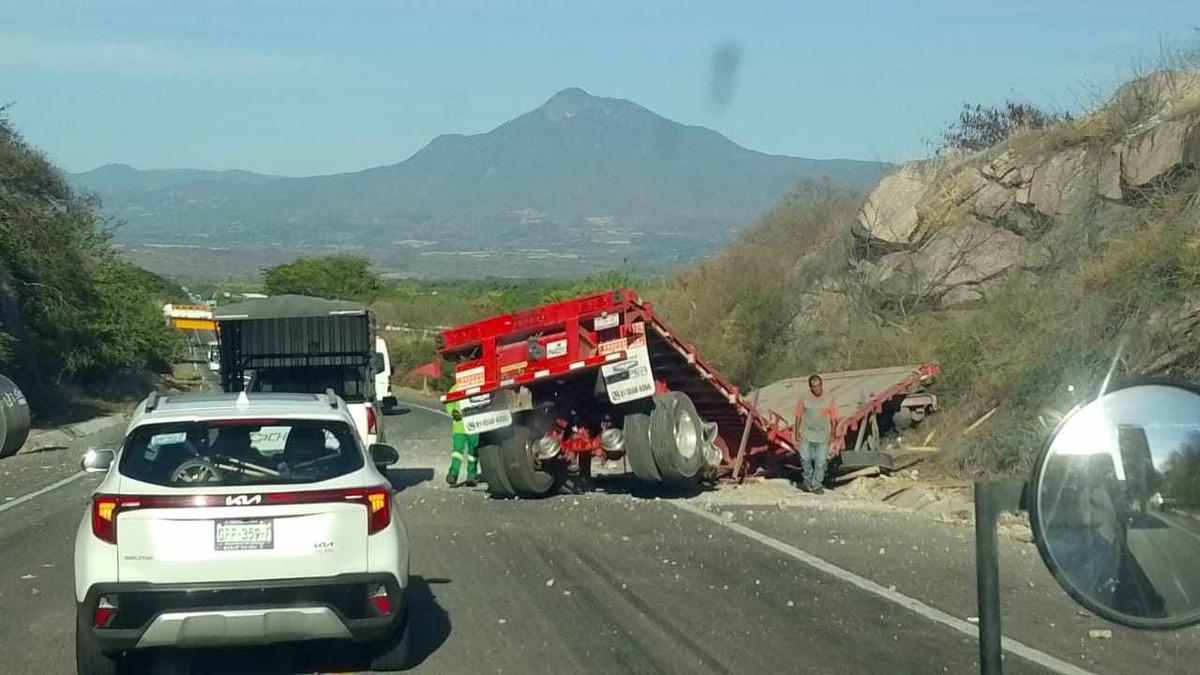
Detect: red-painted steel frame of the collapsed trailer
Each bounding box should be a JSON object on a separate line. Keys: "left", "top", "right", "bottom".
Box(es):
{"left": 438, "top": 288, "right": 937, "bottom": 472}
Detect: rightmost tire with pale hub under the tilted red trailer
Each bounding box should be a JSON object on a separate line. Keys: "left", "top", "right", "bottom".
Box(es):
{"left": 650, "top": 392, "right": 704, "bottom": 485}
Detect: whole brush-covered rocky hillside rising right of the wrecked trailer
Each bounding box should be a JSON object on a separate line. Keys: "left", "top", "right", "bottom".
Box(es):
{"left": 661, "top": 72, "right": 1200, "bottom": 472}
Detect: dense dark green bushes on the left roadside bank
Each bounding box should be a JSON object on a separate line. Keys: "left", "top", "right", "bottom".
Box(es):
{"left": 0, "top": 108, "right": 182, "bottom": 413}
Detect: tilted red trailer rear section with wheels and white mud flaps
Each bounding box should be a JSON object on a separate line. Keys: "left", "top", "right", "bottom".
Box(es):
{"left": 438, "top": 288, "right": 936, "bottom": 497}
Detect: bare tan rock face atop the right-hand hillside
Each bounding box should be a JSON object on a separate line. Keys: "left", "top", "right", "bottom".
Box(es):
{"left": 851, "top": 72, "right": 1200, "bottom": 306}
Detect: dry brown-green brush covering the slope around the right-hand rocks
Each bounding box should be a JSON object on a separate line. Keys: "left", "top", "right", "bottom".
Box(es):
{"left": 648, "top": 68, "right": 1200, "bottom": 476}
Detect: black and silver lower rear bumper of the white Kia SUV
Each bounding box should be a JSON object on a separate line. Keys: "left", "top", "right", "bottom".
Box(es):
{"left": 78, "top": 573, "right": 407, "bottom": 652}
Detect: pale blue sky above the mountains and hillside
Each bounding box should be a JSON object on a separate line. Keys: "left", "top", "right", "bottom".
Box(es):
{"left": 0, "top": 0, "right": 1200, "bottom": 175}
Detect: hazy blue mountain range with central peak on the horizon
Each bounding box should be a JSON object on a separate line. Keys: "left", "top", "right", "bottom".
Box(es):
{"left": 68, "top": 88, "right": 890, "bottom": 274}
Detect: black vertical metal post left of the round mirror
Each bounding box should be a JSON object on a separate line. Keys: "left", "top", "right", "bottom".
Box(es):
{"left": 974, "top": 480, "right": 1003, "bottom": 675}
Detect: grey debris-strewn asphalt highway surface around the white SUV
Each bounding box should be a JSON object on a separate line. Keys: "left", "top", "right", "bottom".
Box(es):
{"left": 0, "top": 396, "right": 1200, "bottom": 674}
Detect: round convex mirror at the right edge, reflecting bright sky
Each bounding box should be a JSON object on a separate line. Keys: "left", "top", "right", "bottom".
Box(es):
{"left": 1028, "top": 383, "right": 1200, "bottom": 629}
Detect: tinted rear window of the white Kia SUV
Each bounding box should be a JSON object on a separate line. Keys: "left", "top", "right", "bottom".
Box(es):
{"left": 120, "top": 419, "right": 364, "bottom": 486}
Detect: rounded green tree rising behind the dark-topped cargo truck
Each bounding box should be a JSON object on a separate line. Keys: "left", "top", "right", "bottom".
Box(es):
{"left": 263, "top": 256, "right": 383, "bottom": 303}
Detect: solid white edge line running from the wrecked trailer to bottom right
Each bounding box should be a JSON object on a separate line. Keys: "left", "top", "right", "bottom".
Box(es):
{"left": 671, "top": 501, "right": 1092, "bottom": 675}
